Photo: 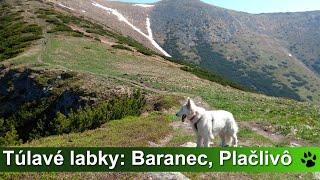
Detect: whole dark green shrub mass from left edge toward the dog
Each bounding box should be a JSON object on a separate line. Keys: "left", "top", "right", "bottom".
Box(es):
{"left": 0, "top": 70, "right": 146, "bottom": 146}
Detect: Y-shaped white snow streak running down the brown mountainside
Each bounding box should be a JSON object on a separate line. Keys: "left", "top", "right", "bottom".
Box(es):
{"left": 91, "top": 2, "right": 171, "bottom": 57}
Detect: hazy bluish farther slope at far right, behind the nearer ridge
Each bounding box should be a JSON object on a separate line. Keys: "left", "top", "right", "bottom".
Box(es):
{"left": 256, "top": 11, "right": 320, "bottom": 71}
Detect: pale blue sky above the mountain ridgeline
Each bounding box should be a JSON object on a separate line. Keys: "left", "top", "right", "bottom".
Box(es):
{"left": 116, "top": 0, "right": 320, "bottom": 13}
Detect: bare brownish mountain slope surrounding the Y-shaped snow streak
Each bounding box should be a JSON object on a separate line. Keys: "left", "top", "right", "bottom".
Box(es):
{"left": 47, "top": 0, "right": 160, "bottom": 53}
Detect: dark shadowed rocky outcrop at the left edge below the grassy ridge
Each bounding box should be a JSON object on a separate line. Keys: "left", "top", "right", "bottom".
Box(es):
{"left": 0, "top": 66, "right": 95, "bottom": 141}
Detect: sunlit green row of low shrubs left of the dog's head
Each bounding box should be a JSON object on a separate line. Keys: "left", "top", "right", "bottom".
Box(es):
{"left": 54, "top": 91, "right": 145, "bottom": 134}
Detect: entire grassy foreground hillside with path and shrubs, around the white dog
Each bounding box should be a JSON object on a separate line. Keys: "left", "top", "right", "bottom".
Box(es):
{"left": 0, "top": 1, "right": 320, "bottom": 179}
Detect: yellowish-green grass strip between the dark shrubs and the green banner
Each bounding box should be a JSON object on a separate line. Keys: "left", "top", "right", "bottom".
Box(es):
{"left": 23, "top": 113, "right": 172, "bottom": 147}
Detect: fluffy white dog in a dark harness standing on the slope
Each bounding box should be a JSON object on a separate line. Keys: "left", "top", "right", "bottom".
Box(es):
{"left": 176, "top": 98, "right": 238, "bottom": 147}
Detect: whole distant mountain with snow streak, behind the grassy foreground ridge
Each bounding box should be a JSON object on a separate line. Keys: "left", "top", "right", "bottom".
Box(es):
{"left": 49, "top": 0, "right": 320, "bottom": 100}
